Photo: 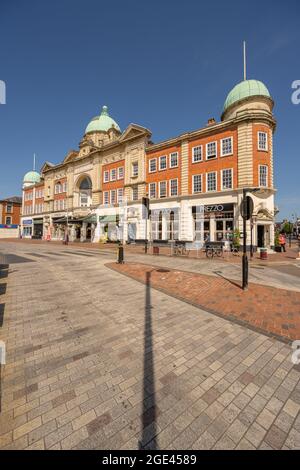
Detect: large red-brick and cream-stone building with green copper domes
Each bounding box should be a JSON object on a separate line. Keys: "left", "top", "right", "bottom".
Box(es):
{"left": 22, "top": 80, "right": 276, "bottom": 248}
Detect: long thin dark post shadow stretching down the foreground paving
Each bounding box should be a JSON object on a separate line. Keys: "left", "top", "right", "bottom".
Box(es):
{"left": 139, "top": 271, "right": 158, "bottom": 450}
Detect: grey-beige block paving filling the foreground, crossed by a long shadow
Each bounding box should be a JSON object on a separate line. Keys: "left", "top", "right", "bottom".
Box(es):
{"left": 0, "top": 244, "right": 300, "bottom": 449}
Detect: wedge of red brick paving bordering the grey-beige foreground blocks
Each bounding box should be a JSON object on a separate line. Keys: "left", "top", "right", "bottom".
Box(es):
{"left": 106, "top": 263, "right": 300, "bottom": 341}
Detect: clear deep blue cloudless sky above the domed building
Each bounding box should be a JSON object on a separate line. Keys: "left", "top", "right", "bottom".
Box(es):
{"left": 0, "top": 0, "right": 300, "bottom": 218}
